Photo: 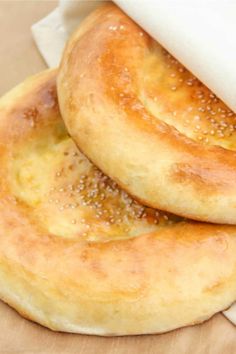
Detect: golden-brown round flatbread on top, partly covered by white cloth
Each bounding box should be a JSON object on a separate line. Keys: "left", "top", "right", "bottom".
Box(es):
{"left": 58, "top": 4, "right": 236, "bottom": 224}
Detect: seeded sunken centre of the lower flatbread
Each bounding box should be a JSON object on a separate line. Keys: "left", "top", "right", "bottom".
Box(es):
{"left": 49, "top": 144, "right": 176, "bottom": 238}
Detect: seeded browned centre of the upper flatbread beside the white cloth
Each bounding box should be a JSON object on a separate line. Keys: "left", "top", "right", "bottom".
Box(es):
{"left": 150, "top": 48, "right": 236, "bottom": 150}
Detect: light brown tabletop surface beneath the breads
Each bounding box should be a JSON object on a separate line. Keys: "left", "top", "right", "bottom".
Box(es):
{"left": 0, "top": 0, "right": 236, "bottom": 354}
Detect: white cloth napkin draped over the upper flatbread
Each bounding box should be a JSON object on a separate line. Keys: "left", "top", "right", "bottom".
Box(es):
{"left": 32, "top": 0, "right": 236, "bottom": 324}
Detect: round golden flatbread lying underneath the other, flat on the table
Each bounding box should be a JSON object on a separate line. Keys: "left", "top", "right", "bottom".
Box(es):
{"left": 0, "top": 71, "right": 236, "bottom": 335}
